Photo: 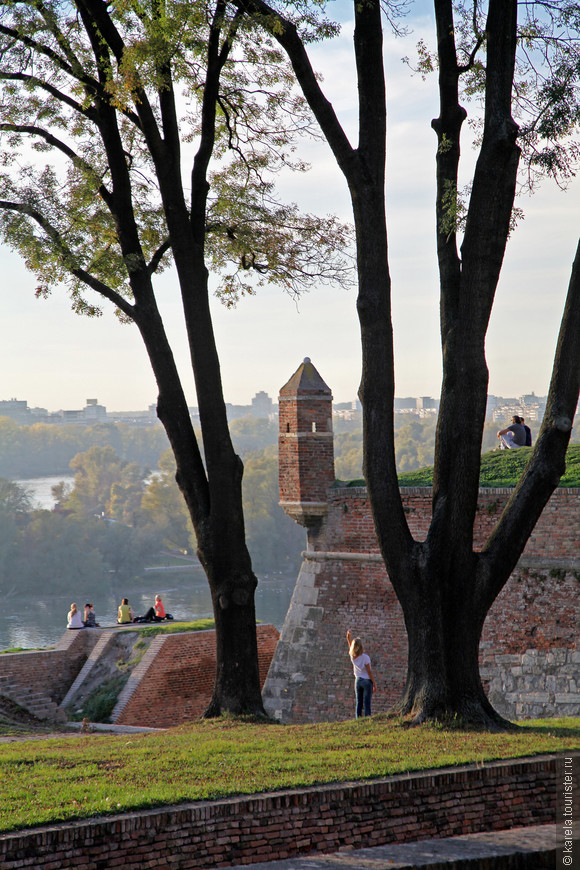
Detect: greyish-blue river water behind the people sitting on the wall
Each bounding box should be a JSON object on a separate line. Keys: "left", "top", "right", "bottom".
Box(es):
{"left": 0, "top": 476, "right": 296, "bottom": 649}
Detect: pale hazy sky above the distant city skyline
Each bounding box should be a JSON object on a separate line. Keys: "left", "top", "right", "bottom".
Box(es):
{"left": 0, "top": 3, "right": 580, "bottom": 411}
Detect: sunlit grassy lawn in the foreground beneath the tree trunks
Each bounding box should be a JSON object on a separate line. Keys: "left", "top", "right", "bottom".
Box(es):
{"left": 0, "top": 715, "right": 580, "bottom": 831}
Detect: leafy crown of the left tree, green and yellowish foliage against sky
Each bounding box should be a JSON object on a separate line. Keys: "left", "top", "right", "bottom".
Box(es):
{"left": 0, "top": 0, "right": 352, "bottom": 318}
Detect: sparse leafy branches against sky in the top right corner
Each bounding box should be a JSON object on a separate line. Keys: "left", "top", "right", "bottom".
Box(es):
{"left": 404, "top": 0, "right": 580, "bottom": 189}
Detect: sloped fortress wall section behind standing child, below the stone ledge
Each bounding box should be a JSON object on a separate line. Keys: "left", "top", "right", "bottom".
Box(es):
{"left": 262, "top": 554, "right": 407, "bottom": 722}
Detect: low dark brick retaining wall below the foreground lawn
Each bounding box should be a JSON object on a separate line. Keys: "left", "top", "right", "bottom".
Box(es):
{"left": 0, "top": 757, "right": 557, "bottom": 870}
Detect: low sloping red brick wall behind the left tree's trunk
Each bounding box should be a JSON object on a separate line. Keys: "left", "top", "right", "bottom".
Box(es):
{"left": 111, "top": 625, "right": 278, "bottom": 728}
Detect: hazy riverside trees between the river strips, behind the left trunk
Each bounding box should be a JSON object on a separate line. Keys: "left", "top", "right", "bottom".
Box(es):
{"left": 0, "top": 426, "right": 304, "bottom": 594}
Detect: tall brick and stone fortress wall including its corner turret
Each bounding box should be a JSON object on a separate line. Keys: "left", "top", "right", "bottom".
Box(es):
{"left": 264, "top": 361, "right": 580, "bottom": 722}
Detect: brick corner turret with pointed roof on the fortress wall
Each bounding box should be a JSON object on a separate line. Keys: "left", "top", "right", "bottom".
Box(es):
{"left": 278, "top": 357, "right": 334, "bottom": 527}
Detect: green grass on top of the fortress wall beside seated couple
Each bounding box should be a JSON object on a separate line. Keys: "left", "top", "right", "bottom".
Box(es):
{"left": 337, "top": 444, "right": 580, "bottom": 487}
